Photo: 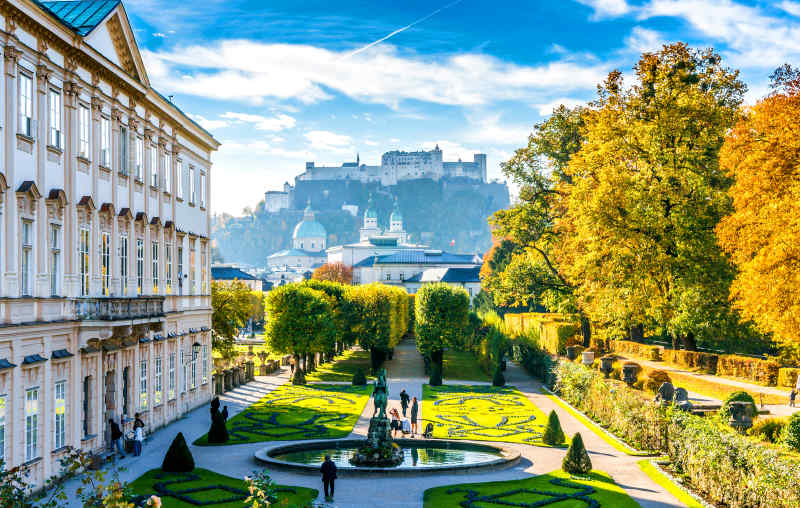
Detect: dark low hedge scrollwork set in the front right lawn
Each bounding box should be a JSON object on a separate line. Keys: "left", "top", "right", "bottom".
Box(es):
{"left": 447, "top": 478, "right": 600, "bottom": 508}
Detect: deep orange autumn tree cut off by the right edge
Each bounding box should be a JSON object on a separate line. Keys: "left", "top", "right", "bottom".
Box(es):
{"left": 717, "top": 66, "right": 800, "bottom": 354}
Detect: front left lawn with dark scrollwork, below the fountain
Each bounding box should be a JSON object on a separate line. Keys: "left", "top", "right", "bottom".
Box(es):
{"left": 128, "top": 468, "right": 319, "bottom": 508}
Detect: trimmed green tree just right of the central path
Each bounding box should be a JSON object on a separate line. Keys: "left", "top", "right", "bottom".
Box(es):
{"left": 414, "top": 283, "right": 469, "bottom": 372}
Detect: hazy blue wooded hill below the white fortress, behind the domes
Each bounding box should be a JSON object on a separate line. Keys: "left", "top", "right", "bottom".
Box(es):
{"left": 212, "top": 178, "right": 509, "bottom": 266}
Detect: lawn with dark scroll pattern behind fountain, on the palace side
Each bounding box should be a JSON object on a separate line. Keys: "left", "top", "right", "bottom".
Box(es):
{"left": 194, "top": 384, "right": 372, "bottom": 446}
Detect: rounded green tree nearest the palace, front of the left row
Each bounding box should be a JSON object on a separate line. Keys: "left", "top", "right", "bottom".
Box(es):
{"left": 264, "top": 283, "right": 336, "bottom": 382}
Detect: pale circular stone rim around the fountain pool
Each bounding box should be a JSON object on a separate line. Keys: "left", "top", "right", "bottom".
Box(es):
{"left": 255, "top": 439, "right": 521, "bottom": 475}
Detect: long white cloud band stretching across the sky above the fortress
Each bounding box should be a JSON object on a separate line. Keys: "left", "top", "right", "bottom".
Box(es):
{"left": 142, "top": 40, "right": 610, "bottom": 108}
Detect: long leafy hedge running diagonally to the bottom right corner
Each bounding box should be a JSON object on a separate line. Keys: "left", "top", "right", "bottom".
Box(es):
{"left": 556, "top": 362, "right": 800, "bottom": 508}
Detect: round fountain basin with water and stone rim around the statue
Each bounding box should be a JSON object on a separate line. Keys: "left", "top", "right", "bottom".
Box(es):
{"left": 255, "top": 439, "right": 520, "bottom": 475}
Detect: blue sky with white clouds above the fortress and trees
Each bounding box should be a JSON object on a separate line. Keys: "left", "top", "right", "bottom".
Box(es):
{"left": 123, "top": 0, "right": 800, "bottom": 215}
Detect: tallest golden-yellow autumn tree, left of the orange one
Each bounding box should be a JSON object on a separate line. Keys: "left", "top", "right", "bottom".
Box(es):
{"left": 557, "top": 43, "right": 746, "bottom": 349}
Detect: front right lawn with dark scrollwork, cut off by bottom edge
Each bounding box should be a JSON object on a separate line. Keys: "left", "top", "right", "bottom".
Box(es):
{"left": 423, "top": 470, "right": 639, "bottom": 508}
